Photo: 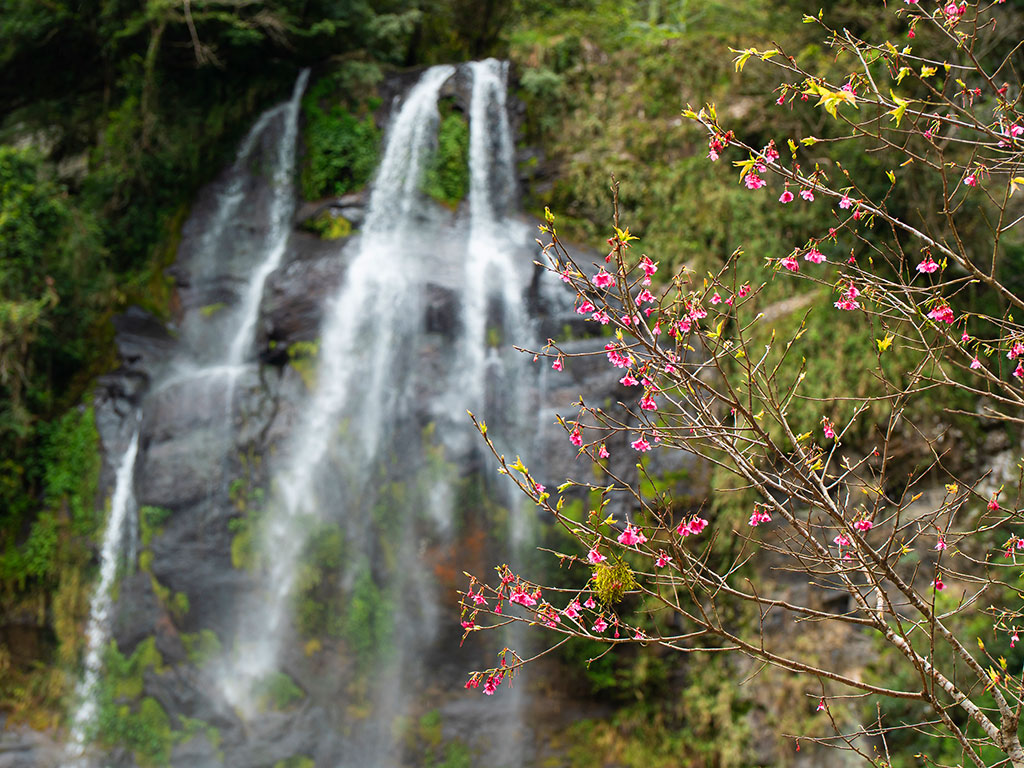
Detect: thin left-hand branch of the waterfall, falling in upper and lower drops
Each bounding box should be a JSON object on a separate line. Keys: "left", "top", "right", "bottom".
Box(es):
{"left": 67, "top": 70, "right": 309, "bottom": 768}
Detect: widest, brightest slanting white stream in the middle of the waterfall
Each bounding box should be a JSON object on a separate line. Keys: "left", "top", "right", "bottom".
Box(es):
{"left": 219, "top": 67, "right": 455, "bottom": 715}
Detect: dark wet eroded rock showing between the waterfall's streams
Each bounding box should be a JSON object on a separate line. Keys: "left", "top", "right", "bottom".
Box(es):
{"left": 70, "top": 61, "right": 712, "bottom": 768}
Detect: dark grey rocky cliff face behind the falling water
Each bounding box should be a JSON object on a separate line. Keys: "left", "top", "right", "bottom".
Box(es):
{"left": 36, "top": 63, "right": 667, "bottom": 768}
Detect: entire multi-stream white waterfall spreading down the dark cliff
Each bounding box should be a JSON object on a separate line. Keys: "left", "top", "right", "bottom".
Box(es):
{"left": 67, "top": 59, "right": 539, "bottom": 768}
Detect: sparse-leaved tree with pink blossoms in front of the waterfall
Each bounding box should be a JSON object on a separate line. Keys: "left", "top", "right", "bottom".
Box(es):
{"left": 461, "top": 0, "right": 1024, "bottom": 766}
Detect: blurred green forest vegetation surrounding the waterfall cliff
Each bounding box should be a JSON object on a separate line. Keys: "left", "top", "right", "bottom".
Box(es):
{"left": 6, "top": 0, "right": 1024, "bottom": 766}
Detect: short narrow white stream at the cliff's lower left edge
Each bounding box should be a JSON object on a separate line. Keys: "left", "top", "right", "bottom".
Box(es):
{"left": 67, "top": 423, "right": 141, "bottom": 768}
